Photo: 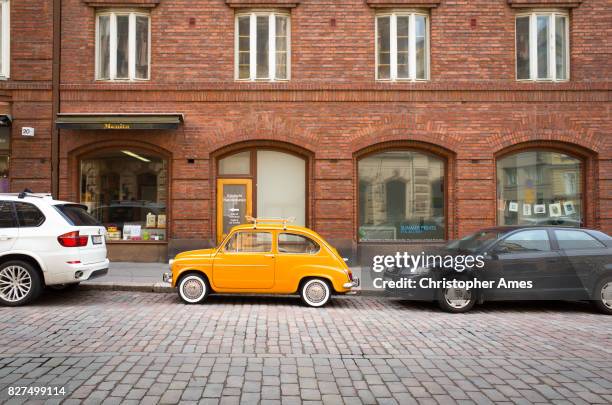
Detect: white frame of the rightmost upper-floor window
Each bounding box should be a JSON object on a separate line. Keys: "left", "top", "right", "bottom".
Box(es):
{"left": 514, "top": 10, "right": 571, "bottom": 82}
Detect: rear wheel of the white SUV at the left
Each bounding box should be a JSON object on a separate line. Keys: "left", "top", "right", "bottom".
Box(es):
{"left": 0, "top": 260, "right": 42, "bottom": 307}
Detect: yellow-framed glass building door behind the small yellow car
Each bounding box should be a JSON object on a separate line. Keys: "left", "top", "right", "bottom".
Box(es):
{"left": 217, "top": 179, "right": 253, "bottom": 243}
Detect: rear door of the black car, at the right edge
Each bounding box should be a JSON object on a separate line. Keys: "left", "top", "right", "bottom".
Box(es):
{"left": 553, "top": 229, "right": 612, "bottom": 299}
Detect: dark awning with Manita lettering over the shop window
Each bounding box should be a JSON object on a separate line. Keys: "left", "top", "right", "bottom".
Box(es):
{"left": 55, "top": 113, "right": 183, "bottom": 130}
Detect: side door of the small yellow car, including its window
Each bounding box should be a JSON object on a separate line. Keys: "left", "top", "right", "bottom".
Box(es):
{"left": 213, "top": 230, "right": 275, "bottom": 290}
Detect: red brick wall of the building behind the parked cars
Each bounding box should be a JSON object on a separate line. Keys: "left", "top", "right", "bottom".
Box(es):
{"left": 0, "top": 0, "right": 612, "bottom": 249}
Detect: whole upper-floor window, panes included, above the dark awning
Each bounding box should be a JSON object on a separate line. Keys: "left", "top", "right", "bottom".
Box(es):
{"left": 96, "top": 11, "right": 151, "bottom": 80}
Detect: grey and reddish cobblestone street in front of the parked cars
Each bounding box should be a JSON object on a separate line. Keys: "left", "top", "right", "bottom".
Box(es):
{"left": 0, "top": 290, "right": 612, "bottom": 405}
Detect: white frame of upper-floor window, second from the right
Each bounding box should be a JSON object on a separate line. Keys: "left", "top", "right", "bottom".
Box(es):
{"left": 374, "top": 10, "right": 430, "bottom": 82}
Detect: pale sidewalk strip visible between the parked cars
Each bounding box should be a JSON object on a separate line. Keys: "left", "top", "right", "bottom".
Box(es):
{"left": 81, "top": 262, "right": 381, "bottom": 295}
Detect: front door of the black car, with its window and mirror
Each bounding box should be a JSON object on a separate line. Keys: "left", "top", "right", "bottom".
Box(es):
{"left": 485, "top": 229, "right": 575, "bottom": 300}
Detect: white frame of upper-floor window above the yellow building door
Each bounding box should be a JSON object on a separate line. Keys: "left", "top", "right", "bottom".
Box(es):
{"left": 234, "top": 10, "right": 291, "bottom": 82}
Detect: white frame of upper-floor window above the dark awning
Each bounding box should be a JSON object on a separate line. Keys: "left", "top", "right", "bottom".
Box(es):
{"left": 95, "top": 9, "right": 152, "bottom": 82}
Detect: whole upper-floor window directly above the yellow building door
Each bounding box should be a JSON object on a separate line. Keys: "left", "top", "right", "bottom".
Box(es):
{"left": 235, "top": 12, "right": 290, "bottom": 81}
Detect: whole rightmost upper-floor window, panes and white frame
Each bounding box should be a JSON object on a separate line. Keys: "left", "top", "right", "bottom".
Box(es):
{"left": 516, "top": 12, "right": 569, "bottom": 81}
